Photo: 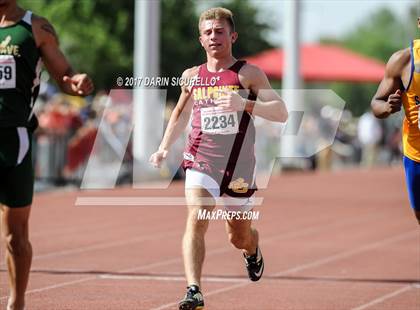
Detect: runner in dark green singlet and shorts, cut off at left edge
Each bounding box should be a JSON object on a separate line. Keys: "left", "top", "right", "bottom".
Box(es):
{"left": 0, "top": 0, "right": 93, "bottom": 310}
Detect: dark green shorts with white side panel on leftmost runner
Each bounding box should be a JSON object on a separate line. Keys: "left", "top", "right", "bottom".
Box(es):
{"left": 0, "top": 127, "right": 34, "bottom": 208}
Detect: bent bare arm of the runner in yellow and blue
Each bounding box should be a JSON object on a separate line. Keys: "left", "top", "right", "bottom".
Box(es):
{"left": 371, "top": 49, "right": 410, "bottom": 118}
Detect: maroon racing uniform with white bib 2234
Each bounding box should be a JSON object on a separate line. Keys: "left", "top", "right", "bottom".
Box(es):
{"left": 183, "top": 61, "right": 257, "bottom": 197}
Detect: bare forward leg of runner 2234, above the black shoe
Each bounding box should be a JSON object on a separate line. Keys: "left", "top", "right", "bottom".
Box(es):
{"left": 182, "top": 188, "right": 215, "bottom": 286}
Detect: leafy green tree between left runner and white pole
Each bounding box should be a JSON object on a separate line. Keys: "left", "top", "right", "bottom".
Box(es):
{"left": 19, "top": 0, "right": 134, "bottom": 89}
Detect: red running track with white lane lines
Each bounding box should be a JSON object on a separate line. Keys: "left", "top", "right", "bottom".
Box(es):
{"left": 0, "top": 167, "right": 420, "bottom": 310}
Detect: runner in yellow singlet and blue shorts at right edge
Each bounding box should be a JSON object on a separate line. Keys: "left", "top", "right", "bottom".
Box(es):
{"left": 371, "top": 18, "right": 420, "bottom": 224}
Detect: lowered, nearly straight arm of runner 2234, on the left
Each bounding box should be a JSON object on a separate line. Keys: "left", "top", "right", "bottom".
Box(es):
{"left": 149, "top": 67, "right": 197, "bottom": 167}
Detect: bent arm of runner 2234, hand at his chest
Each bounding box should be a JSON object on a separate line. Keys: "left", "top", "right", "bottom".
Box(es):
{"left": 215, "top": 64, "right": 288, "bottom": 122}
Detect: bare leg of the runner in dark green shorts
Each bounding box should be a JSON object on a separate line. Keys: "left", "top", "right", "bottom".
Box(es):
{"left": 0, "top": 206, "right": 32, "bottom": 310}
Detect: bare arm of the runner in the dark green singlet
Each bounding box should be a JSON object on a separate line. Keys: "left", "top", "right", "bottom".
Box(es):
{"left": 32, "top": 16, "right": 93, "bottom": 96}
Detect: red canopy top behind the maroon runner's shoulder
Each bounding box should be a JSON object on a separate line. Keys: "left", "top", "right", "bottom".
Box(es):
{"left": 245, "top": 45, "right": 385, "bottom": 82}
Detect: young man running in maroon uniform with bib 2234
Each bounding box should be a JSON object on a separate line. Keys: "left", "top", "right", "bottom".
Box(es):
{"left": 150, "top": 8, "right": 287, "bottom": 310}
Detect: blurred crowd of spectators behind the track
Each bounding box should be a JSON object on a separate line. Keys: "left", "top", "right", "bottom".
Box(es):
{"left": 33, "top": 86, "right": 402, "bottom": 190}
